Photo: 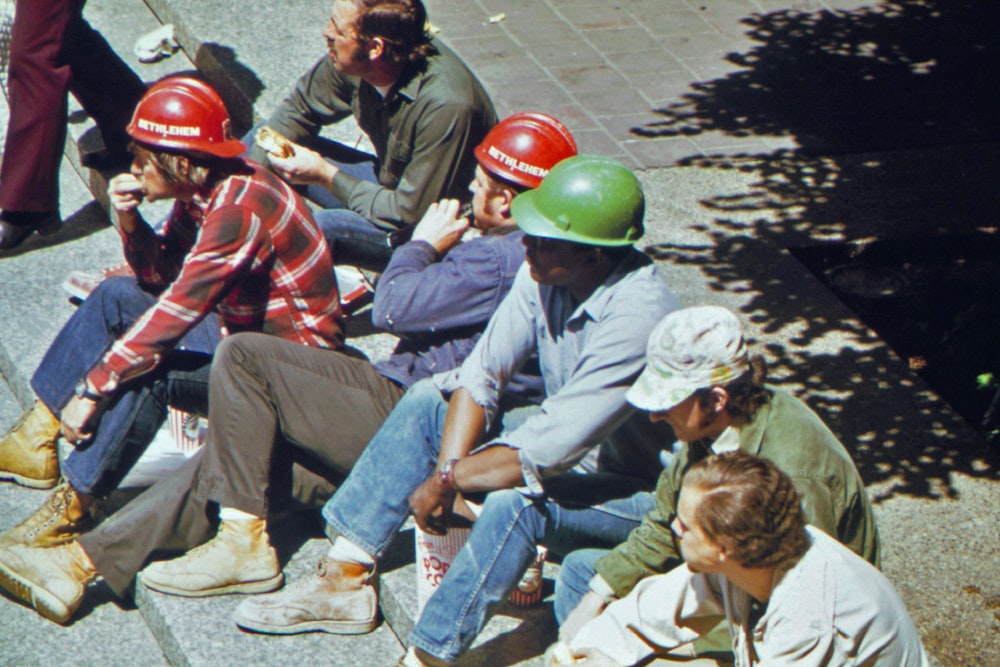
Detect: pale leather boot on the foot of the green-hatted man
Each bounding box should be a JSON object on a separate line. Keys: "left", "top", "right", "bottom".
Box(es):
{"left": 233, "top": 558, "right": 378, "bottom": 635}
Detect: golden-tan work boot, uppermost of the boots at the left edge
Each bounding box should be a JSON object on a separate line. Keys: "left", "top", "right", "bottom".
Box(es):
{"left": 0, "top": 401, "right": 59, "bottom": 489}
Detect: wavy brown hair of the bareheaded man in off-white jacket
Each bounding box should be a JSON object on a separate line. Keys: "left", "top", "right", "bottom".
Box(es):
{"left": 683, "top": 450, "right": 809, "bottom": 567}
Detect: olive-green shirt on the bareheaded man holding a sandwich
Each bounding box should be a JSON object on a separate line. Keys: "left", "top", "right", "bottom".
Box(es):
{"left": 256, "top": 40, "right": 497, "bottom": 230}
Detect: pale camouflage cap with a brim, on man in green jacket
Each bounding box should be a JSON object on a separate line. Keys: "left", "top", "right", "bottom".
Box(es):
{"left": 625, "top": 306, "right": 750, "bottom": 412}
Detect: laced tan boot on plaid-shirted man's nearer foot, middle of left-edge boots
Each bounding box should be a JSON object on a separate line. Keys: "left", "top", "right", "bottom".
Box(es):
{"left": 0, "top": 482, "right": 94, "bottom": 547}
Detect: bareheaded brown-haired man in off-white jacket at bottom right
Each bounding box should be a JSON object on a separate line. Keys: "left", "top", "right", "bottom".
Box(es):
{"left": 546, "top": 450, "right": 929, "bottom": 667}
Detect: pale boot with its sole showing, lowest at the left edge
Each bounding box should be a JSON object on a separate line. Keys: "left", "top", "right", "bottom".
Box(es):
{"left": 0, "top": 542, "right": 97, "bottom": 623}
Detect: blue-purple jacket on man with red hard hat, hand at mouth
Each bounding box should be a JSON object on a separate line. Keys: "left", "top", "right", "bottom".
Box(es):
{"left": 372, "top": 229, "right": 542, "bottom": 403}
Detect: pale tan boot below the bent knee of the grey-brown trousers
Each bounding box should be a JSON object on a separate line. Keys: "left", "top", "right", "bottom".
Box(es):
{"left": 139, "top": 519, "right": 284, "bottom": 597}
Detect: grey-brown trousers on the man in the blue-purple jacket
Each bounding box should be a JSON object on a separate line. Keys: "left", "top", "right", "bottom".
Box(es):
{"left": 80, "top": 333, "right": 404, "bottom": 595}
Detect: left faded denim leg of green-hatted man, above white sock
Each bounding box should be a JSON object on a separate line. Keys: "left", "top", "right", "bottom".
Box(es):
{"left": 323, "top": 379, "right": 448, "bottom": 558}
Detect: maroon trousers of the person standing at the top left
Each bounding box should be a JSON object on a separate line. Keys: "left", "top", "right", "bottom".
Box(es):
{"left": 0, "top": 0, "right": 145, "bottom": 212}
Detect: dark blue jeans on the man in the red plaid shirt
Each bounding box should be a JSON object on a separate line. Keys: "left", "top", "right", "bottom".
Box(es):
{"left": 31, "top": 278, "right": 219, "bottom": 496}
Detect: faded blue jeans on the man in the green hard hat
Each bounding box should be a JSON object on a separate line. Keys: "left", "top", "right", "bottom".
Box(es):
{"left": 323, "top": 380, "right": 654, "bottom": 662}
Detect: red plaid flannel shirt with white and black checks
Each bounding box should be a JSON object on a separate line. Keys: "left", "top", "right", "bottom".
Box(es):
{"left": 88, "top": 162, "right": 344, "bottom": 394}
